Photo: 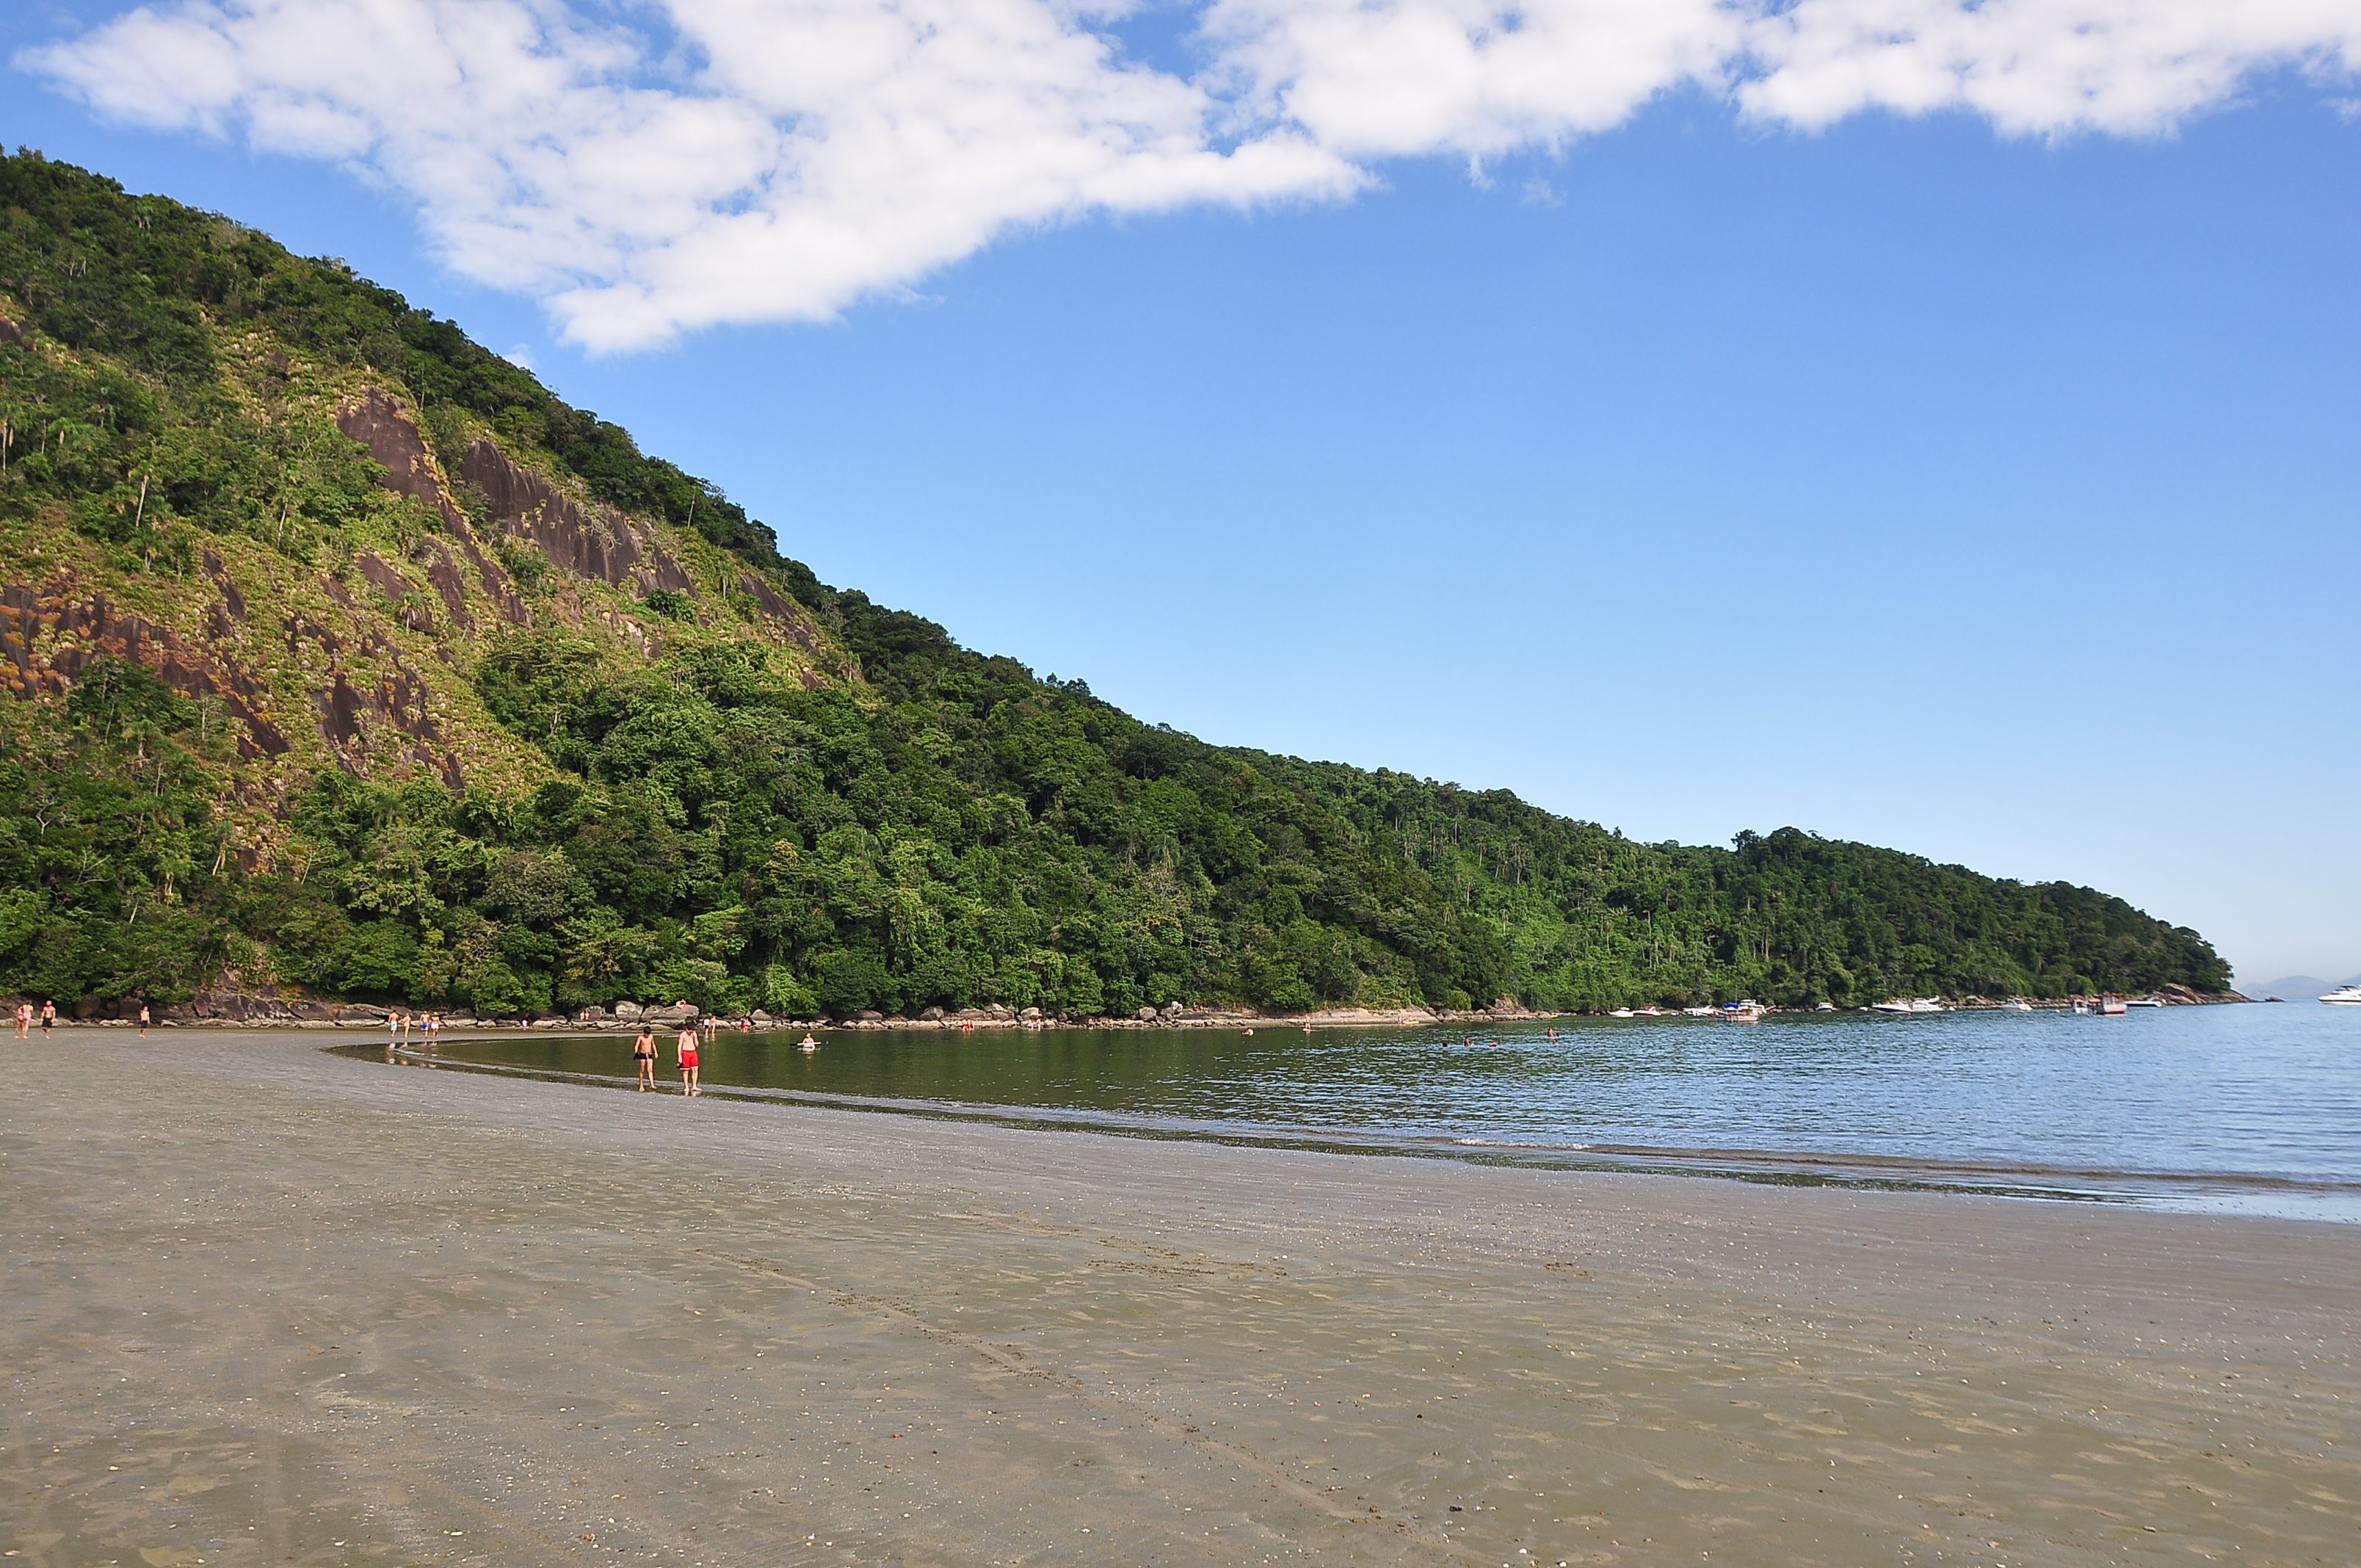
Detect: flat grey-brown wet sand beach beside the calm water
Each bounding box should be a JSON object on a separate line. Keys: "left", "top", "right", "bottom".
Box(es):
{"left": 0, "top": 1030, "right": 2361, "bottom": 1568}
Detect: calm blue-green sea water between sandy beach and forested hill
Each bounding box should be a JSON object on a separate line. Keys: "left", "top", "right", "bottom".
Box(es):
{"left": 401, "top": 1001, "right": 2361, "bottom": 1221}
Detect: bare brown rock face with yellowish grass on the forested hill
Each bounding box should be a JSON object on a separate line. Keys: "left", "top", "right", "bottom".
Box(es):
{"left": 0, "top": 363, "right": 850, "bottom": 857}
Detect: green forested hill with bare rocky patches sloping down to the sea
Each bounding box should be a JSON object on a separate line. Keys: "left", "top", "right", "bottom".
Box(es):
{"left": 0, "top": 153, "right": 2227, "bottom": 1015}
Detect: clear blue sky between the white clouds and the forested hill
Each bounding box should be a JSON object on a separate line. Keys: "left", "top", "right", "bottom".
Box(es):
{"left": 0, "top": 0, "right": 2361, "bottom": 982}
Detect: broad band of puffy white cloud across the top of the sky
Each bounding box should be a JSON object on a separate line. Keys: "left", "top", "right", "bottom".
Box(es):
{"left": 17, "top": 0, "right": 2361, "bottom": 349}
